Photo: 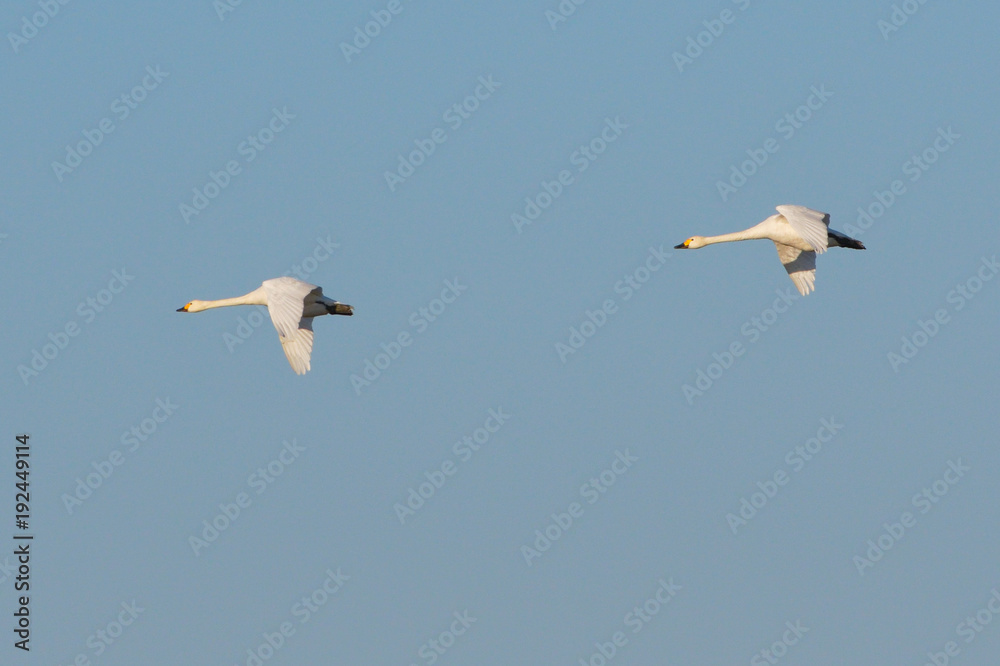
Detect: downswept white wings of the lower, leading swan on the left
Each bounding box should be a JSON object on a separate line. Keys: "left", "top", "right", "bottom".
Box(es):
{"left": 263, "top": 277, "right": 323, "bottom": 375}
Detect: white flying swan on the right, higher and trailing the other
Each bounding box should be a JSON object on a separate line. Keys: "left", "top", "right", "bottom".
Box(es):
{"left": 674, "top": 205, "right": 865, "bottom": 296}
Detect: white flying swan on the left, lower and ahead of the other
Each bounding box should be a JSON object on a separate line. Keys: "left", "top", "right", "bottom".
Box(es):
{"left": 177, "top": 277, "right": 354, "bottom": 375}
